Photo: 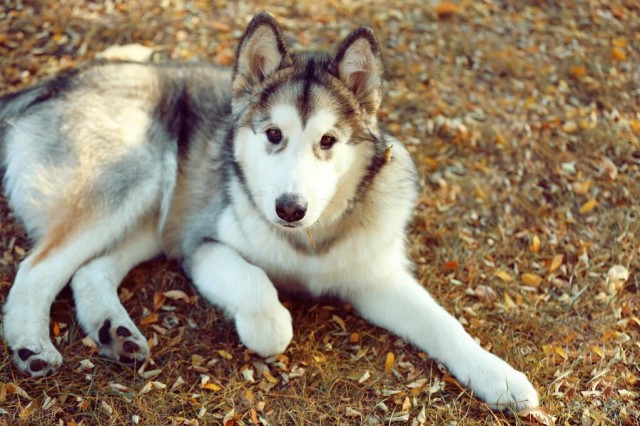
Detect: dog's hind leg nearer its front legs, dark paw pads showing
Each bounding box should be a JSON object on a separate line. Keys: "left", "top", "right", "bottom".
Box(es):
{"left": 71, "top": 222, "right": 160, "bottom": 364}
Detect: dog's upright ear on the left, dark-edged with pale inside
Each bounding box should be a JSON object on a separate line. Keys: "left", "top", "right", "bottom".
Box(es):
{"left": 233, "top": 12, "right": 291, "bottom": 94}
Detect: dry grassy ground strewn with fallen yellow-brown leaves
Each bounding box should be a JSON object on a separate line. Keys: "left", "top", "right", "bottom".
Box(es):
{"left": 0, "top": 0, "right": 640, "bottom": 425}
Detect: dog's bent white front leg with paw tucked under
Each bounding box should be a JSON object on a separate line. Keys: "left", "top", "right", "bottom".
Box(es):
{"left": 189, "top": 243, "right": 293, "bottom": 357}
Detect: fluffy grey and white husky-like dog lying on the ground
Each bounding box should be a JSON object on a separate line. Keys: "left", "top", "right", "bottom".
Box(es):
{"left": 0, "top": 13, "right": 538, "bottom": 410}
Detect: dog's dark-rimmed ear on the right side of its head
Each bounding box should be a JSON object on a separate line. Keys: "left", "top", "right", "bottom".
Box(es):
{"left": 334, "top": 27, "right": 384, "bottom": 116}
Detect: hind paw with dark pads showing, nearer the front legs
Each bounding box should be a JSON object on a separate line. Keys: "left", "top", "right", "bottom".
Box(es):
{"left": 89, "top": 319, "right": 150, "bottom": 364}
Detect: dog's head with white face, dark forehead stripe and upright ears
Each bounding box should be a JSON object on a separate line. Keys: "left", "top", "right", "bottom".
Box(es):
{"left": 232, "top": 14, "right": 384, "bottom": 228}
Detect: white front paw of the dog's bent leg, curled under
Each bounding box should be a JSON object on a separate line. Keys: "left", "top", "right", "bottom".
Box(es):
{"left": 235, "top": 303, "right": 293, "bottom": 357}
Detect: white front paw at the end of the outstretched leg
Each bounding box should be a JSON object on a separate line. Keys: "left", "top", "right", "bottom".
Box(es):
{"left": 468, "top": 352, "right": 539, "bottom": 411}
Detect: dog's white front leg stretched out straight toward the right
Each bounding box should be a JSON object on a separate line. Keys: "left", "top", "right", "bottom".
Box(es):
{"left": 348, "top": 271, "right": 538, "bottom": 410}
